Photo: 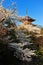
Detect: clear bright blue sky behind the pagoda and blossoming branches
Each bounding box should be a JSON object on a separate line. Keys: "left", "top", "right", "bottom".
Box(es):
{"left": 3, "top": 0, "right": 43, "bottom": 26}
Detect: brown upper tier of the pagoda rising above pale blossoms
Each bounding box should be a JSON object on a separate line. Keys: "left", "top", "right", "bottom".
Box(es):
{"left": 19, "top": 11, "right": 35, "bottom": 25}
